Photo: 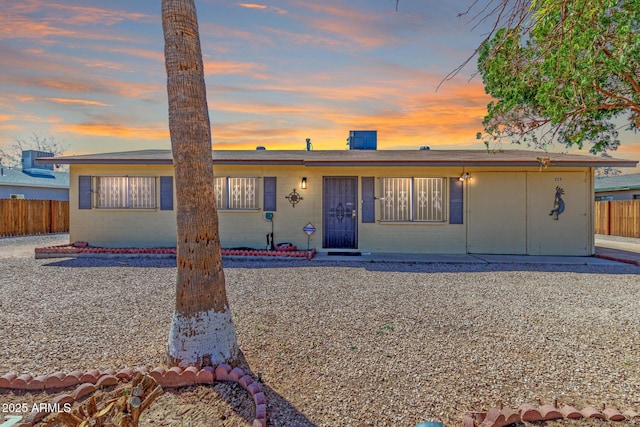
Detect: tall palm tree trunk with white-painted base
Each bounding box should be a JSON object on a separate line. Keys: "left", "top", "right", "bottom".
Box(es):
{"left": 162, "top": 0, "right": 238, "bottom": 367}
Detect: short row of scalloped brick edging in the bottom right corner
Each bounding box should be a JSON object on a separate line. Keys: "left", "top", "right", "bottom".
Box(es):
{"left": 462, "top": 403, "right": 640, "bottom": 427}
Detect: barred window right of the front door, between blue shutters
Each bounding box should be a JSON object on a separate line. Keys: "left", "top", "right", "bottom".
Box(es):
{"left": 380, "top": 178, "right": 445, "bottom": 222}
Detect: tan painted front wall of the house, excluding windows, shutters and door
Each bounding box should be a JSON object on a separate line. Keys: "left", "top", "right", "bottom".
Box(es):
{"left": 70, "top": 160, "right": 594, "bottom": 255}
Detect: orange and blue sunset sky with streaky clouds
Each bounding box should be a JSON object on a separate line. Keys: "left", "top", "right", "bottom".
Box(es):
{"left": 0, "top": 0, "right": 640, "bottom": 172}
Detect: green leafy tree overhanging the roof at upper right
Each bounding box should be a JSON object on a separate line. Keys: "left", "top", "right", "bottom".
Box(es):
{"left": 470, "top": 0, "right": 640, "bottom": 154}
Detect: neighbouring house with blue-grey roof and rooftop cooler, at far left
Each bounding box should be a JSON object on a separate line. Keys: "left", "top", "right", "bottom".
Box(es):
{"left": 0, "top": 150, "right": 69, "bottom": 200}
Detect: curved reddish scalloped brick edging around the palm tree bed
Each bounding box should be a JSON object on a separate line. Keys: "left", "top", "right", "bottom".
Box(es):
{"left": 0, "top": 364, "right": 267, "bottom": 427}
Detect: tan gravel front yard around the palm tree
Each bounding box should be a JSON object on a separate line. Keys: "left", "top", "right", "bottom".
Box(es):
{"left": 0, "top": 234, "right": 640, "bottom": 427}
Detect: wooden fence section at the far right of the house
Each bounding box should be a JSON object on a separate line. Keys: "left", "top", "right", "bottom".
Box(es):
{"left": 594, "top": 200, "right": 640, "bottom": 238}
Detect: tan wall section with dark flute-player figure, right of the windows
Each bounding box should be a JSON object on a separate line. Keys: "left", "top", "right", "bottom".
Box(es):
{"left": 468, "top": 168, "right": 594, "bottom": 255}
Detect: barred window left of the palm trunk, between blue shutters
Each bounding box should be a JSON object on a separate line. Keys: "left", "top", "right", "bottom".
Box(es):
{"left": 94, "top": 176, "right": 157, "bottom": 209}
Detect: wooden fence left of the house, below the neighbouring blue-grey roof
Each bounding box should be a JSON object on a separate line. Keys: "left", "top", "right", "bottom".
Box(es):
{"left": 0, "top": 199, "right": 69, "bottom": 236}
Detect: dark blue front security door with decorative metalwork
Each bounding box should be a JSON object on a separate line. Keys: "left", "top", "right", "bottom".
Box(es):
{"left": 322, "top": 176, "right": 358, "bottom": 249}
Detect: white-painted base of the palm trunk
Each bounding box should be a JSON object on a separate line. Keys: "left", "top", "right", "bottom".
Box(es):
{"left": 168, "top": 307, "right": 238, "bottom": 367}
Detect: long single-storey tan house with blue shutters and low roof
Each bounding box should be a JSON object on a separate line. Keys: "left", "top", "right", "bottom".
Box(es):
{"left": 46, "top": 140, "right": 637, "bottom": 255}
